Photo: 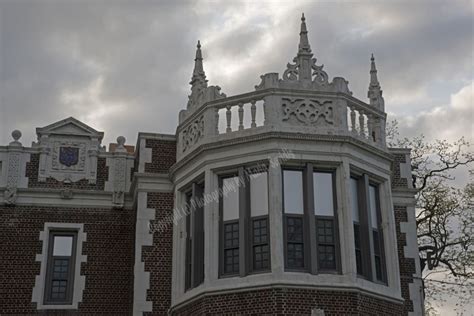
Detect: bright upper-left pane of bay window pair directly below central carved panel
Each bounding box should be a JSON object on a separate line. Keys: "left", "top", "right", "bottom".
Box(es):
{"left": 283, "top": 170, "right": 303, "bottom": 214}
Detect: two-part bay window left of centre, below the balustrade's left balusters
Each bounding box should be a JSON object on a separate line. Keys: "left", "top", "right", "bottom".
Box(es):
{"left": 220, "top": 168, "right": 270, "bottom": 276}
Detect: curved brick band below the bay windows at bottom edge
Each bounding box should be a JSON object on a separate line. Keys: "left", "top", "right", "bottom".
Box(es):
{"left": 172, "top": 288, "right": 403, "bottom": 316}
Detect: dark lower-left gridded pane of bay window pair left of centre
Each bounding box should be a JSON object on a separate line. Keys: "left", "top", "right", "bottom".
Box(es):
{"left": 224, "top": 222, "right": 239, "bottom": 274}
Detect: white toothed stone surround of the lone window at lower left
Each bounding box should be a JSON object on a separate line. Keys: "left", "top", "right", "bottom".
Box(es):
{"left": 31, "top": 223, "right": 87, "bottom": 310}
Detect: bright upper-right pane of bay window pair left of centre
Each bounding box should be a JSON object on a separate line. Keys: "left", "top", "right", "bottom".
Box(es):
{"left": 250, "top": 172, "right": 268, "bottom": 217}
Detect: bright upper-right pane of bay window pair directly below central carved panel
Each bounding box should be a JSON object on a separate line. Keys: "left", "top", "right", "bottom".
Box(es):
{"left": 313, "top": 172, "right": 334, "bottom": 216}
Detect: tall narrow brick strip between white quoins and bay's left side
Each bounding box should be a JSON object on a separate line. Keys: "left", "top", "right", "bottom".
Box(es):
{"left": 142, "top": 192, "right": 174, "bottom": 315}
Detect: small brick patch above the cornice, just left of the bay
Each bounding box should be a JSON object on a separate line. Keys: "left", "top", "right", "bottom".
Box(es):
{"left": 145, "top": 139, "right": 176, "bottom": 173}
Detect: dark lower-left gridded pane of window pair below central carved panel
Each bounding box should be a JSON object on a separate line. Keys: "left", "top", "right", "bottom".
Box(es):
{"left": 286, "top": 216, "right": 304, "bottom": 269}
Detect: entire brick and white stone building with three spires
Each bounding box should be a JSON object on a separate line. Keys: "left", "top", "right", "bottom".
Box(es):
{"left": 0, "top": 16, "right": 423, "bottom": 315}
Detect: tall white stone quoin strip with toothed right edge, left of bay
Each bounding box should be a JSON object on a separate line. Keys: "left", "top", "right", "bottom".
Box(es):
{"left": 133, "top": 192, "right": 156, "bottom": 315}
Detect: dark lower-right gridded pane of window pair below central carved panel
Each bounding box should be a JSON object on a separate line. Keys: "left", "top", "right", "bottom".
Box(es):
{"left": 316, "top": 218, "right": 336, "bottom": 270}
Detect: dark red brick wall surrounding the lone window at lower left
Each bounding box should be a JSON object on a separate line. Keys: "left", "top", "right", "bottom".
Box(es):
{"left": 0, "top": 206, "right": 135, "bottom": 315}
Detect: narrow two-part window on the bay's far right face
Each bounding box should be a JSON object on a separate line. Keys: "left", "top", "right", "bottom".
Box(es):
{"left": 350, "top": 175, "right": 386, "bottom": 283}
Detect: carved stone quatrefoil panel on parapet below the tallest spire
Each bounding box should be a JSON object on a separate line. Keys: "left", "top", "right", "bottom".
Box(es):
{"left": 282, "top": 98, "right": 334, "bottom": 125}
